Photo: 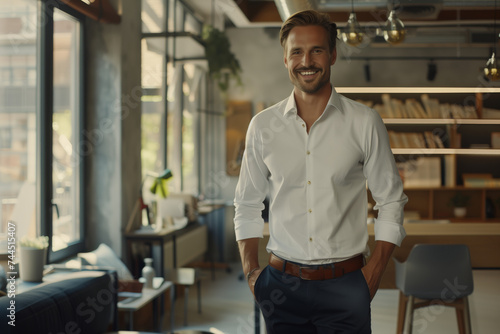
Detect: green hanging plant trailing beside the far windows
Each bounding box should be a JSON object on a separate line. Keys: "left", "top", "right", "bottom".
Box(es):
{"left": 202, "top": 26, "right": 241, "bottom": 92}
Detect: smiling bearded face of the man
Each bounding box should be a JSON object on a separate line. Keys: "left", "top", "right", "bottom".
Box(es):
{"left": 285, "top": 26, "right": 337, "bottom": 94}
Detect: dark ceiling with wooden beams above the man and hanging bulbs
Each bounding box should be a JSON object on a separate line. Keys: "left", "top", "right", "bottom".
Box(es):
{"left": 183, "top": 0, "right": 500, "bottom": 47}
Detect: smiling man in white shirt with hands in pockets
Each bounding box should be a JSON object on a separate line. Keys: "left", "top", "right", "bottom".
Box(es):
{"left": 234, "top": 11, "right": 407, "bottom": 334}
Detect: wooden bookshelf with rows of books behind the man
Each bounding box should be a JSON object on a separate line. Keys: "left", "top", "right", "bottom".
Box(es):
{"left": 336, "top": 87, "right": 500, "bottom": 223}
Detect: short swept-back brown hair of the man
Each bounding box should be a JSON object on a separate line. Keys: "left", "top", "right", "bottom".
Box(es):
{"left": 280, "top": 10, "right": 337, "bottom": 52}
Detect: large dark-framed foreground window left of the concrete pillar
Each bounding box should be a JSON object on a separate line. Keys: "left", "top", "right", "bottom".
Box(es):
{"left": 0, "top": 0, "right": 84, "bottom": 260}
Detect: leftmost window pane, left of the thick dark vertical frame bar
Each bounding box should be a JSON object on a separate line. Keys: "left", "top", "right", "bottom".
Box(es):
{"left": 0, "top": 0, "right": 37, "bottom": 243}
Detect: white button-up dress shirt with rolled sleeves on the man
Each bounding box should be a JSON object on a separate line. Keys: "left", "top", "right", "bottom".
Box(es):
{"left": 234, "top": 88, "right": 408, "bottom": 264}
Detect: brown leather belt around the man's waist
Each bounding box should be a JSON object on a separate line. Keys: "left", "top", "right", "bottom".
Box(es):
{"left": 269, "top": 254, "right": 364, "bottom": 281}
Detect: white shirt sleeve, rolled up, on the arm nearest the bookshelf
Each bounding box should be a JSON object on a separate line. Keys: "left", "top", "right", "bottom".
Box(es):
{"left": 364, "top": 110, "right": 408, "bottom": 246}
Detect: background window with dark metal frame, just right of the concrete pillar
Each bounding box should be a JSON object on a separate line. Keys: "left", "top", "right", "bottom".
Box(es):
{"left": 141, "top": 0, "right": 207, "bottom": 195}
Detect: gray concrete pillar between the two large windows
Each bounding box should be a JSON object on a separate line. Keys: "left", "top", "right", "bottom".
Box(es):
{"left": 85, "top": 0, "right": 141, "bottom": 254}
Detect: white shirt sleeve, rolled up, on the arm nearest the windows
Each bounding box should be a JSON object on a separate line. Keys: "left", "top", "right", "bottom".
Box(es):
{"left": 234, "top": 117, "right": 269, "bottom": 240}
